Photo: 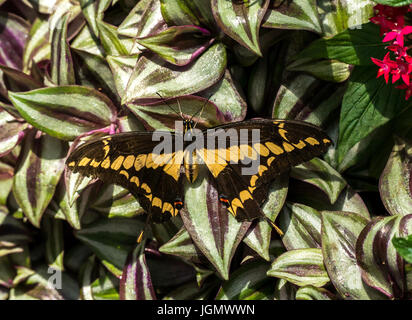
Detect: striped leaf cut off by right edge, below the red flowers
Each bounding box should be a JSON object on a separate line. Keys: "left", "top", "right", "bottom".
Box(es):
{"left": 379, "top": 139, "right": 412, "bottom": 215}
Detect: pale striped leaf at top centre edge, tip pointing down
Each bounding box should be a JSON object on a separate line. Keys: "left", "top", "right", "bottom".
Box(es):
{"left": 212, "top": 0, "right": 270, "bottom": 56}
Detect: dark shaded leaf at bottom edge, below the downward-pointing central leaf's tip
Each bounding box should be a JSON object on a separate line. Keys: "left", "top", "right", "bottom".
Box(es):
{"left": 216, "top": 261, "right": 273, "bottom": 300}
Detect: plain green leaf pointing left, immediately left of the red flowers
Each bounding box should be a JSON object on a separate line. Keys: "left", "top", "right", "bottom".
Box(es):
{"left": 296, "top": 23, "right": 386, "bottom": 66}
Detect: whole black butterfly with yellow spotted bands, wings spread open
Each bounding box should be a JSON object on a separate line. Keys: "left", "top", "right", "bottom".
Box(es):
{"left": 66, "top": 119, "right": 332, "bottom": 223}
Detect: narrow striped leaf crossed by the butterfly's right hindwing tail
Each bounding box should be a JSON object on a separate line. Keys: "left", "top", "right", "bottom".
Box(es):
{"left": 243, "top": 175, "right": 289, "bottom": 261}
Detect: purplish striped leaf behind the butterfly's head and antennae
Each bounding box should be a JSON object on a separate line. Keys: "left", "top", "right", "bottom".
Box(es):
{"left": 128, "top": 96, "right": 225, "bottom": 132}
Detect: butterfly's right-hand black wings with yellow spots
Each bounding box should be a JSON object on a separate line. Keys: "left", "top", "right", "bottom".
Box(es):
{"left": 202, "top": 119, "right": 332, "bottom": 221}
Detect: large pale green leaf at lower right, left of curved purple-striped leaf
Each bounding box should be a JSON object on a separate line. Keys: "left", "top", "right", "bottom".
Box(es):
{"left": 321, "top": 211, "right": 383, "bottom": 300}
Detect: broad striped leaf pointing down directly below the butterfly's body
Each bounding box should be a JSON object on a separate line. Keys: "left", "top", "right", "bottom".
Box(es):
{"left": 181, "top": 179, "right": 250, "bottom": 280}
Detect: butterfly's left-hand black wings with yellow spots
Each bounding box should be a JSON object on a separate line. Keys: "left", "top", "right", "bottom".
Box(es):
{"left": 67, "top": 132, "right": 183, "bottom": 222}
